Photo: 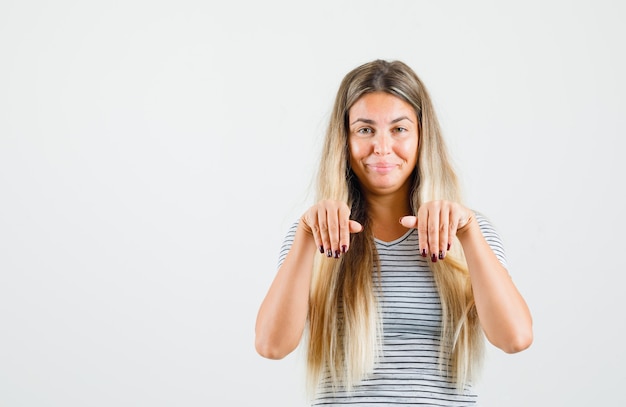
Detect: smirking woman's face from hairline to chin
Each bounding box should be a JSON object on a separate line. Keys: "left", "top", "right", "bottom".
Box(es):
{"left": 348, "top": 92, "right": 419, "bottom": 199}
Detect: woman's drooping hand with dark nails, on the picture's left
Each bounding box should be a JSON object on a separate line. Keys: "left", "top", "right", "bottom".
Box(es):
{"left": 300, "top": 200, "right": 363, "bottom": 259}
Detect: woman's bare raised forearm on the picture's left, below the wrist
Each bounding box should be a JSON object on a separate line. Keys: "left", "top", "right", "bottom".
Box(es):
{"left": 255, "top": 225, "right": 316, "bottom": 359}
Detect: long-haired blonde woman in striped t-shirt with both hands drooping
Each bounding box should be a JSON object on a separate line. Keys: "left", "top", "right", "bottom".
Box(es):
{"left": 256, "top": 60, "right": 532, "bottom": 406}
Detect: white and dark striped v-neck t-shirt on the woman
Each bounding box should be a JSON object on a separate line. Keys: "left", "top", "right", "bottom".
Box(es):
{"left": 279, "top": 213, "right": 506, "bottom": 406}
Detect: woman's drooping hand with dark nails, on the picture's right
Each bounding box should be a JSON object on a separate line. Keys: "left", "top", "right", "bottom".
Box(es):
{"left": 400, "top": 201, "right": 474, "bottom": 262}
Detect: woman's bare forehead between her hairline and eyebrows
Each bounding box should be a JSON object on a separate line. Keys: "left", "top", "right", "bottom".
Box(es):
{"left": 348, "top": 92, "right": 417, "bottom": 124}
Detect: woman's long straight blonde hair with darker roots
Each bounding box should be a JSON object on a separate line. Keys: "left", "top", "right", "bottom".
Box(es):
{"left": 307, "top": 60, "right": 484, "bottom": 394}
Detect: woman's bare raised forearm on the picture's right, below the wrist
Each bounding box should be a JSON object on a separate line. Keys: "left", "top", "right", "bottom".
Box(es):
{"left": 458, "top": 222, "right": 532, "bottom": 353}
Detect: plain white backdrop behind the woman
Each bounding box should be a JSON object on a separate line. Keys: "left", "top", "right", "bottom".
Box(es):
{"left": 0, "top": 0, "right": 626, "bottom": 407}
